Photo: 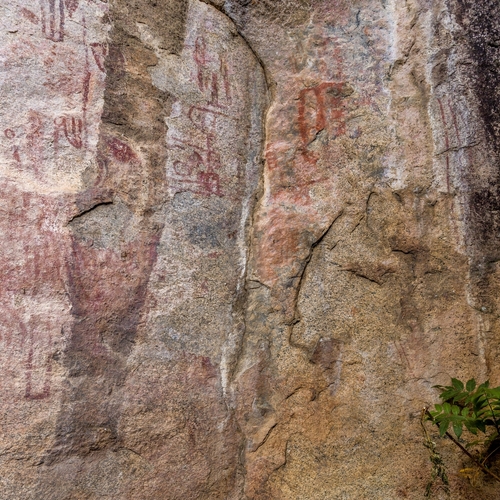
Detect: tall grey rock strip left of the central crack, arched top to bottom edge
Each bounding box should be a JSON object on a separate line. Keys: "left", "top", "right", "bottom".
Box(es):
{"left": 109, "top": 1, "right": 267, "bottom": 498}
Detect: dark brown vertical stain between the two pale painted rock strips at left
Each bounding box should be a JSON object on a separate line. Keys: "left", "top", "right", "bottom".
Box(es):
{"left": 46, "top": 0, "right": 187, "bottom": 462}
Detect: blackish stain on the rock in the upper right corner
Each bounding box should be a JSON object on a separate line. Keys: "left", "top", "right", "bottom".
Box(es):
{"left": 455, "top": 0, "right": 500, "bottom": 266}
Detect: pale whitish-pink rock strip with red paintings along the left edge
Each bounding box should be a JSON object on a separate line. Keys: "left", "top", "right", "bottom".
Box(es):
{"left": 0, "top": 2, "right": 106, "bottom": 498}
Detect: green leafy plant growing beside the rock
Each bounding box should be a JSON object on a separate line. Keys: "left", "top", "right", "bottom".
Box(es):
{"left": 422, "top": 378, "right": 500, "bottom": 496}
